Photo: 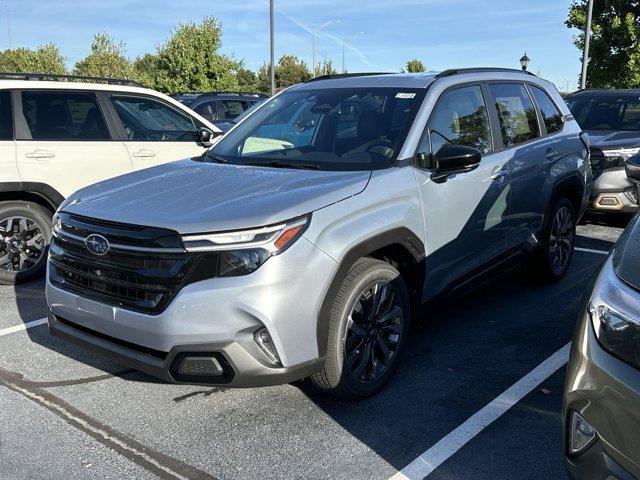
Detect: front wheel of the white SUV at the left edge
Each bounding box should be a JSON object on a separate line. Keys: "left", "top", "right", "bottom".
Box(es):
{"left": 0, "top": 202, "right": 52, "bottom": 285}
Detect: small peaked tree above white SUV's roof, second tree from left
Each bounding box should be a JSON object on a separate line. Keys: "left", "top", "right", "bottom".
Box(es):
{"left": 73, "top": 33, "right": 133, "bottom": 78}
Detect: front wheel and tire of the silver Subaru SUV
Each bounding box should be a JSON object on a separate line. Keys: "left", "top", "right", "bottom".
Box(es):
{"left": 311, "top": 258, "right": 411, "bottom": 400}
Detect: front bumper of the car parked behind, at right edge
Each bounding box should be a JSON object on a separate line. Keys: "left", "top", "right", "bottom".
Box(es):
{"left": 589, "top": 167, "right": 639, "bottom": 213}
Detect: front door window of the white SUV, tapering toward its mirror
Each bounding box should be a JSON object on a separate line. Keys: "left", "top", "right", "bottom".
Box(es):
{"left": 111, "top": 95, "right": 198, "bottom": 142}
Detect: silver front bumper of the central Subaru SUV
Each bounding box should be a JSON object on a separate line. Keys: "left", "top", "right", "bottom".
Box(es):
{"left": 47, "top": 237, "right": 338, "bottom": 387}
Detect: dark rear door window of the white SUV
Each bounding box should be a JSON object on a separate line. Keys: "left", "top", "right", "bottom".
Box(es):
{"left": 22, "top": 91, "right": 109, "bottom": 141}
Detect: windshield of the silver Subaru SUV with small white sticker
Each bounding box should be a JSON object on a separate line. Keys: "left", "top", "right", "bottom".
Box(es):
{"left": 205, "top": 88, "right": 424, "bottom": 170}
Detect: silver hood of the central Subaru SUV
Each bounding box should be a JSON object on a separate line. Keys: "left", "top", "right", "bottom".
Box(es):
{"left": 62, "top": 160, "right": 371, "bottom": 234}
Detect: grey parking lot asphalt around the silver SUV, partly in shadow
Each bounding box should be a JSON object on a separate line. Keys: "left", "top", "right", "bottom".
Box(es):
{"left": 0, "top": 220, "right": 623, "bottom": 479}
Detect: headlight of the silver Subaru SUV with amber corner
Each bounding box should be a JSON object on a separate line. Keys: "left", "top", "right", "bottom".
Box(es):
{"left": 182, "top": 216, "right": 310, "bottom": 277}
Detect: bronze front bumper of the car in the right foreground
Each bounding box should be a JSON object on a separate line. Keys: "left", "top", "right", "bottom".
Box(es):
{"left": 563, "top": 264, "right": 640, "bottom": 480}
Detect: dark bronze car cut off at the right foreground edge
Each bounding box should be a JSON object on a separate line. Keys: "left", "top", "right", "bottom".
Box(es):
{"left": 563, "top": 156, "right": 640, "bottom": 480}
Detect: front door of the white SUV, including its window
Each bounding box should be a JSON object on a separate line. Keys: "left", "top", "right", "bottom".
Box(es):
{"left": 110, "top": 93, "right": 205, "bottom": 170}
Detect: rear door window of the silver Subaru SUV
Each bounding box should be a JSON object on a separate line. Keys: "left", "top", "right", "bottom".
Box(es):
{"left": 489, "top": 83, "right": 540, "bottom": 147}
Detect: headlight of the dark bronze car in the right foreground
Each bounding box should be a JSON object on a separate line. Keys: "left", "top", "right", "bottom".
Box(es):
{"left": 589, "top": 305, "right": 640, "bottom": 369}
